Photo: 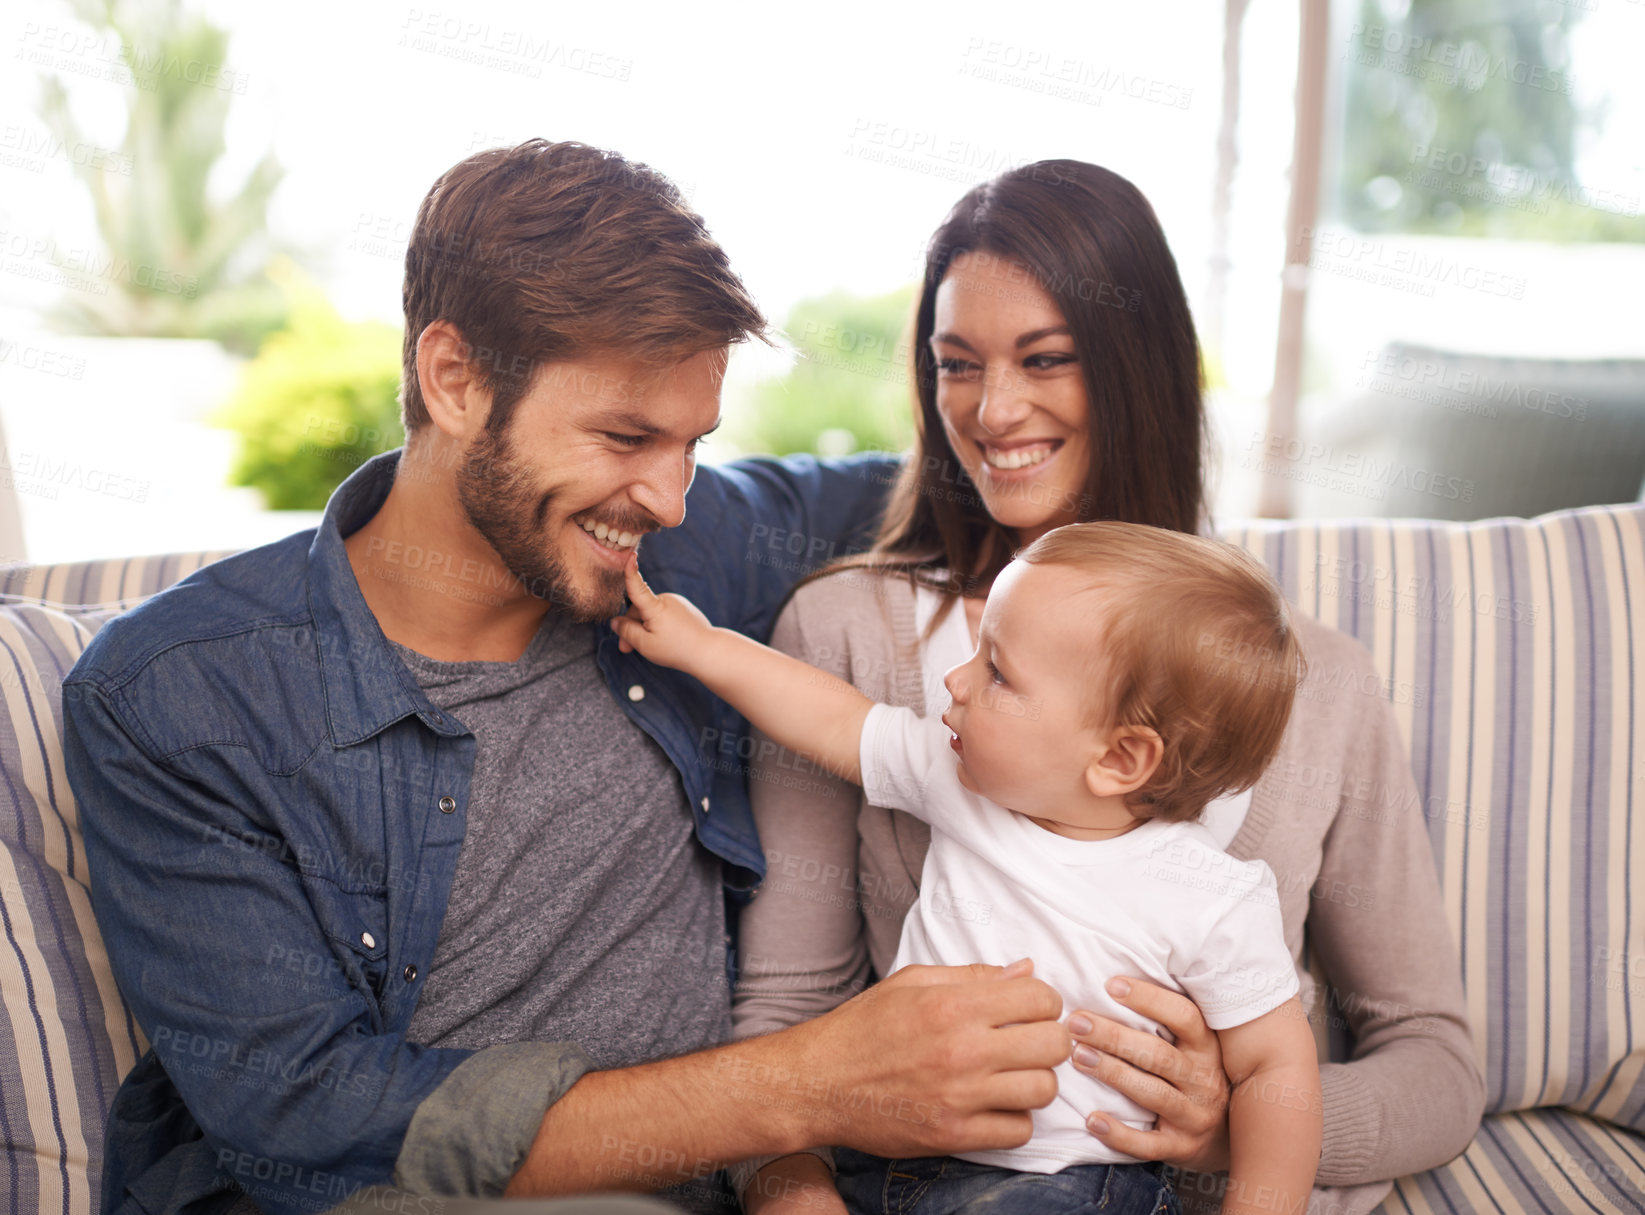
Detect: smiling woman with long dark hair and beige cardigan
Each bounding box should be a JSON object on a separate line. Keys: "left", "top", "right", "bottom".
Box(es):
{"left": 734, "top": 161, "right": 1484, "bottom": 1212}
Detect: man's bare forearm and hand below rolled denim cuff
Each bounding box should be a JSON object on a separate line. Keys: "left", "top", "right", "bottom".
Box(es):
{"left": 507, "top": 963, "right": 1069, "bottom": 1197}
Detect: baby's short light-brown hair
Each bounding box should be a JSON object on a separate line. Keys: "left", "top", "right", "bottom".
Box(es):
{"left": 1018, "top": 523, "right": 1304, "bottom": 820}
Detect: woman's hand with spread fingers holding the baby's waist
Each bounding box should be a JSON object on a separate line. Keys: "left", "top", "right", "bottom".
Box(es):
{"left": 1066, "top": 978, "right": 1229, "bottom": 1172}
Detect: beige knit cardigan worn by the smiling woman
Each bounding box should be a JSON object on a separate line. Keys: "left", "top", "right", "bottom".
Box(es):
{"left": 734, "top": 571, "right": 1485, "bottom": 1215}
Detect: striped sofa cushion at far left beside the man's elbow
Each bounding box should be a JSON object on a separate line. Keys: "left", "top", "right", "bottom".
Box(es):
{"left": 0, "top": 603, "right": 128, "bottom": 1215}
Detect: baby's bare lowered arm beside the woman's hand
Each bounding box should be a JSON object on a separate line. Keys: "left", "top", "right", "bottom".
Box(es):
{"left": 1217, "top": 996, "right": 1324, "bottom": 1215}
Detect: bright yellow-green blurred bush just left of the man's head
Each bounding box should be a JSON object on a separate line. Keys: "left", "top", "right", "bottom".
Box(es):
{"left": 215, "top": 261, "right": 405, "bottom": 510}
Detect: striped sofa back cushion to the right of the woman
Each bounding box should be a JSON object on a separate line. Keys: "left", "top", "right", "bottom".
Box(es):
{"left": 1224, "top": 505, "right": 1645, "bottom": 1131}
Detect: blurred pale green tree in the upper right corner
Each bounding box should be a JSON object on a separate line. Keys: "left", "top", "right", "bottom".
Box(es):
{"left": 1337, "top": 0, "right": 1645, "bottom": 240}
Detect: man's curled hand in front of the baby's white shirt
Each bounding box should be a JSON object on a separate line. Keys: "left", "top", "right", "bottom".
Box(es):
{"left": 790, "top": 959, "right": 1073, "bottom": 1157}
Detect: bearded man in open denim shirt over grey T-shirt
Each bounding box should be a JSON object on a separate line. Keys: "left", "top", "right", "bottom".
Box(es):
{"left": 64, "top": 140, "right": 1068, "bottom": 1213}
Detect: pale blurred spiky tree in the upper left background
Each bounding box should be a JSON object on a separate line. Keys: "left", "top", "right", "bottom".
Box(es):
{"left": 41, "top": 0, "right": 285, "bottom": 353}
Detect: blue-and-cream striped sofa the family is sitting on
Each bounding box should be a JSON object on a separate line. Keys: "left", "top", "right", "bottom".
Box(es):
{"left": 0, "top": 505, "right": 1645, "bottom": 1215}
